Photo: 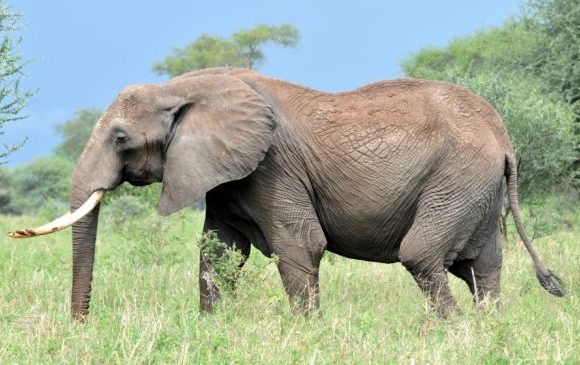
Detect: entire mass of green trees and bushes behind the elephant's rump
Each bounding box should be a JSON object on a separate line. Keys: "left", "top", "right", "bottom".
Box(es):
{"left": 402, "top": 0, "right": 580, "bottom": 197}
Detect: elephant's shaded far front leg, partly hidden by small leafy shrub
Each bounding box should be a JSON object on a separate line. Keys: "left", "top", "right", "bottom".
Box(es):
{"left": 199, "top": 213, "right": 251, "bottom": 313}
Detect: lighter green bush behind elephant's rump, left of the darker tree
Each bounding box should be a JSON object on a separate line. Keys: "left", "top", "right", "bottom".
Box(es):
{"left": 402, "top": 20, "right": 580, "bottom": 200}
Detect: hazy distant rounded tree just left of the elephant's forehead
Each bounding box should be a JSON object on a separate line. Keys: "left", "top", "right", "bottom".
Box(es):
{"left": 54, "top": 108, "right": 103, "bottom": 162}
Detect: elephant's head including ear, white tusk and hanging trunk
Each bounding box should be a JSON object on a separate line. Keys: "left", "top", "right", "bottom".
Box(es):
{"left": 11, "top": 74, "right": 276, "bottom": 319}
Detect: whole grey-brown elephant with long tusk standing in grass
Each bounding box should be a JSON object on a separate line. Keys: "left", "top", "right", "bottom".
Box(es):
{"left": 10, "top": 68, "right": 565, "bottom": 320}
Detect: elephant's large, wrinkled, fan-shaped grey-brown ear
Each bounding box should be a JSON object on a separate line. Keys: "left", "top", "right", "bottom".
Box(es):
{"left": 159, "top": 75, "right": 276, "bottom": 215}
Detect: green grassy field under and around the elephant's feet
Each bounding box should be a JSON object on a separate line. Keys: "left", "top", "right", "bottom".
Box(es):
{"left": 0, "top": 200, "right": 580, "bottom": 364}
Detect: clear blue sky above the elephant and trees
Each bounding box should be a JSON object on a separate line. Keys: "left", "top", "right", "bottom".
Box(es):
{"left": 2, "top": 0, "right": 520, "bottom": 166}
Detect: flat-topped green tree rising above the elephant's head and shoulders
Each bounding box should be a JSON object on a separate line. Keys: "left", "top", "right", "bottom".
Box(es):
{"left": 153, "top": 24, "right": 300, "bottom": 77}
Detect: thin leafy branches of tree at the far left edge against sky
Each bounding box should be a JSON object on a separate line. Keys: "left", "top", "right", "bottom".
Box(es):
{"left": 0, "top": 1, "right": 32, "bottom": 164}
